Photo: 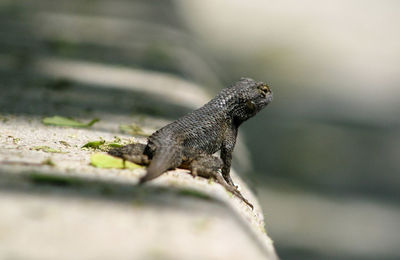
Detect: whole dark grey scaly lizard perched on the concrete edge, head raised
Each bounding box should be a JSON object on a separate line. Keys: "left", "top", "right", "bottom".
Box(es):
{"left": 108, "top": 78, "right": 273, "bottom": 208}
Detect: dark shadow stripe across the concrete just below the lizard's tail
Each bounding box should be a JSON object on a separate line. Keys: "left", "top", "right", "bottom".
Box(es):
{"left": 0, "top": 170, "right": 219, "bottom": 211}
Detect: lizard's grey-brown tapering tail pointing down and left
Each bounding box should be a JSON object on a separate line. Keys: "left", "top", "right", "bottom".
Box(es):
{"left": 139, "top": 147, "right": 182, "bottom": 184}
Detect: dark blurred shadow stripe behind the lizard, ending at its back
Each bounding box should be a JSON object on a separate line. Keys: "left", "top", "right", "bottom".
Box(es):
{"left": 0, "top": 71, "right": 191, "bottom": 120}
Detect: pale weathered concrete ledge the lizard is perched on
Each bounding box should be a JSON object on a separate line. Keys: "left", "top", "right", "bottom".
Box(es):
{"left": 0, "top": 116, "right": 276, "bottom": 259}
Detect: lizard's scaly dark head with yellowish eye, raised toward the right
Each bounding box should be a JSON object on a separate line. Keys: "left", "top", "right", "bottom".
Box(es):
{"left": 232, "top": 78, "right": 272, "bottom": 122}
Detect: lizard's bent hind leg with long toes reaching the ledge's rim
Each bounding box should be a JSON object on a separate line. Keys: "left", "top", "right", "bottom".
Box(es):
{"left": 189, "top": 155, "right": 254, "bottom": 209}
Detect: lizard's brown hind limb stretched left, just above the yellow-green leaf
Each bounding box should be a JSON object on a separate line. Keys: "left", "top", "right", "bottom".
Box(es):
{"left": 108, "top": 143, "right": 150, "bottom": 165}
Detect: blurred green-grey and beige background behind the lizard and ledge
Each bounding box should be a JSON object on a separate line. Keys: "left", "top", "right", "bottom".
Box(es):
{"left": 0, "top": 0, "right": 400, "bottom": 259}
